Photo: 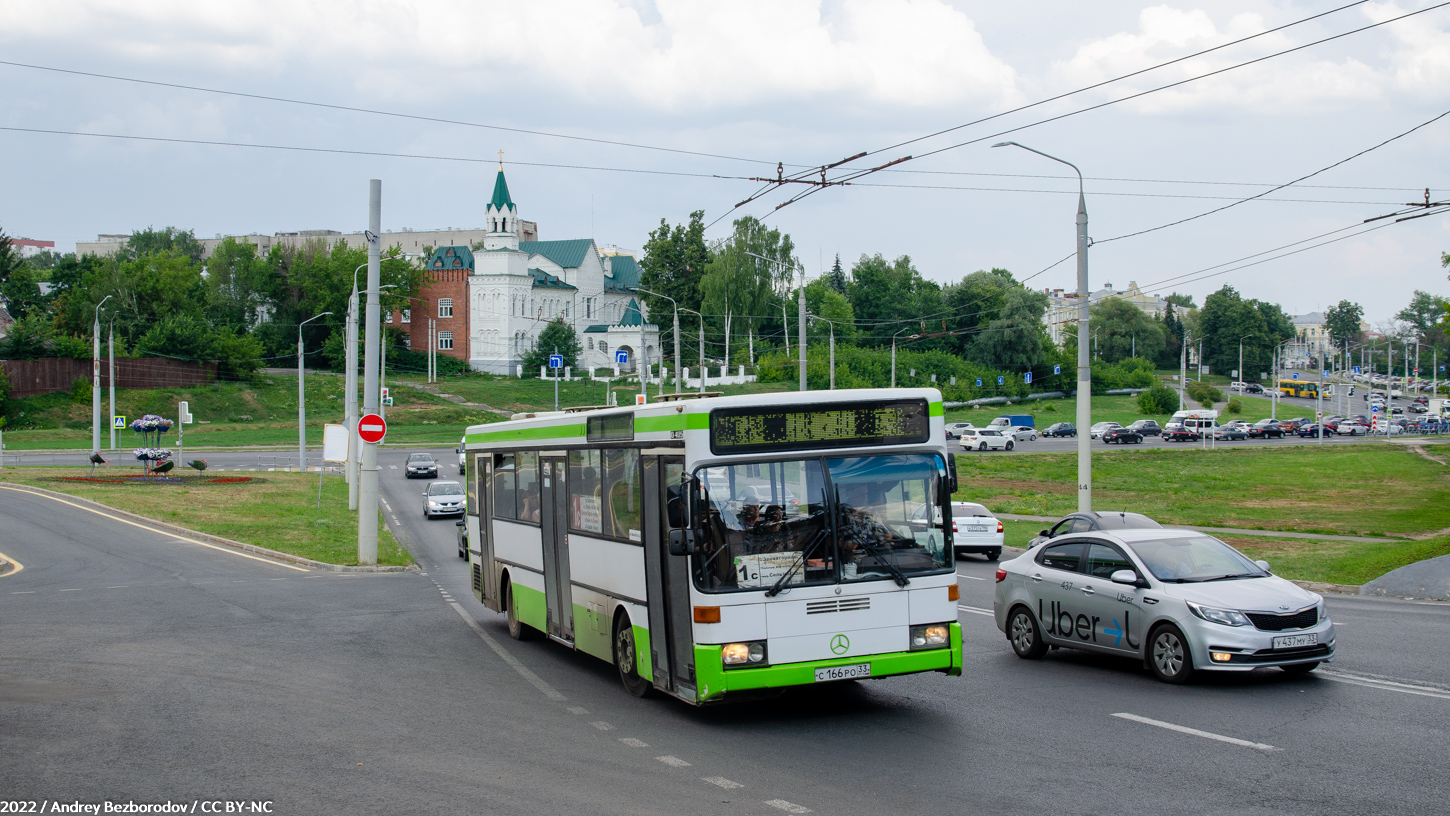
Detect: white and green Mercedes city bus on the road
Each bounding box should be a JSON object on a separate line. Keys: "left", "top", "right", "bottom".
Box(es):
{"left": 464, "top": 388, "right": 961, "bottom": 704}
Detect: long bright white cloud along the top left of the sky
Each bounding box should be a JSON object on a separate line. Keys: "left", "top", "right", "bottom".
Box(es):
{"left": 0, "top": 0, "right": 1018, "bottom": 112}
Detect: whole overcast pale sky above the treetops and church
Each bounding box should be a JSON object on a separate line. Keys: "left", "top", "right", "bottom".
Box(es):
{"left": 0, "top": 0, "right": 1450, "bottom": 323}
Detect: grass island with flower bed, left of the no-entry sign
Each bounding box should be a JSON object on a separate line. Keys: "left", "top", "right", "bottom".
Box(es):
{"left": 0, "top": 467, "right": 413, "bottom": 565}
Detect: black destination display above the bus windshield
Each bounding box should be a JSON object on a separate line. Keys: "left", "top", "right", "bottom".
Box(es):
{"left": 711, "top": 400, "right": 931, "bottom": 455}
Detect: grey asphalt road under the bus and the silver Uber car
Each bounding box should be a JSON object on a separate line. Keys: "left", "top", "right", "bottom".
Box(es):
{"left": 0, "top": 449, "right": 1450, "bottom": 815}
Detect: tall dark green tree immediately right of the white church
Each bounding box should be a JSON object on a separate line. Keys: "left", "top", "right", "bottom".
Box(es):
{"left": 639, "top": 210, "right": 711, "bottom": 357}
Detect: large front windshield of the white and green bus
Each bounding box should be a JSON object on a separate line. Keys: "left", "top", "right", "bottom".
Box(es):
{"left": 695, "top": 454, "right": 951, "bottom": 591}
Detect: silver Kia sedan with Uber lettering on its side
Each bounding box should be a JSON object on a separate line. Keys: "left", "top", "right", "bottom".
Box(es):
{"left": 992, "top": 529, "right": 1334, "bottom": 683}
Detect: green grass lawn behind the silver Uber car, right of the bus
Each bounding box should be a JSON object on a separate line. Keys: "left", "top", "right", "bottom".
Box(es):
{"left": 956, "top": 445, "right": 1450, "bottom": 536}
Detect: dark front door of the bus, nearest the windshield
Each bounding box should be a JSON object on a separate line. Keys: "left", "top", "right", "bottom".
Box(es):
{"left": 644, "top": 457, "right": 695, "bottom": 701}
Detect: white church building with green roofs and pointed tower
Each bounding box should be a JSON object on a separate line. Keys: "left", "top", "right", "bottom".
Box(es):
{"left": 455, "top": 167, "right": 660, "bottom": 374}
